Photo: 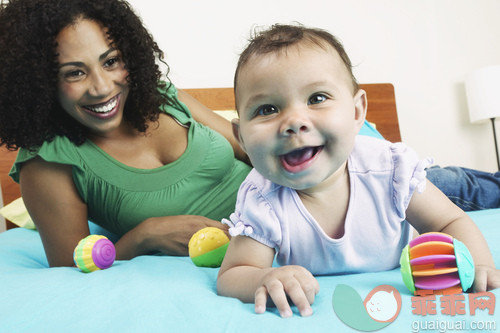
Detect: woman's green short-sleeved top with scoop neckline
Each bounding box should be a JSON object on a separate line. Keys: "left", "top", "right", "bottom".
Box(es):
{"left": 10, "top": 86, "right": 254, "bottom": 235}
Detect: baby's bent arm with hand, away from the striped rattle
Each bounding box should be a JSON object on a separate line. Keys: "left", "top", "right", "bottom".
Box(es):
{"left": 217, "top": 236, "right": 319, "bottom": 317}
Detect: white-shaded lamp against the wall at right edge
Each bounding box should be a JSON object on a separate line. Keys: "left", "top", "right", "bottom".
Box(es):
{"left": 465, "top": 66, "right": 500, "bottom": 170}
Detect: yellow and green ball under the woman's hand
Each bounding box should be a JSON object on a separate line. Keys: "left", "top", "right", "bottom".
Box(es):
{"left": 188, "top": 227, "right": 229, "bottom": 267}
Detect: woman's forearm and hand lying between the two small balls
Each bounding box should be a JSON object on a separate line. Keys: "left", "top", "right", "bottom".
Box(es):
{"left": 115, "top": 215, "right": 227, "bottom": 260}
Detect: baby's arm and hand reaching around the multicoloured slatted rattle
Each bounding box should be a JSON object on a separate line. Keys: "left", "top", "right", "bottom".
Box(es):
{"left": 406, "top": 181, "right": 500, "bottom": 292}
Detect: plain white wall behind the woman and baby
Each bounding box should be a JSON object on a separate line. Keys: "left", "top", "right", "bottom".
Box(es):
{"left": 130, "top": 0, "right": 500, "bottom": 171}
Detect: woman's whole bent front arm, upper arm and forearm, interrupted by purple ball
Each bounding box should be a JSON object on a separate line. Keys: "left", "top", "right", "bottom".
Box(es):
{"left": 20, "top": 157, "right": 227, "bottom": 267}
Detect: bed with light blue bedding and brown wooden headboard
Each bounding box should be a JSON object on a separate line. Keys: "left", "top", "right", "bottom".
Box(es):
{"left": 0, "top": 84, "right": 500, "bottom": 332}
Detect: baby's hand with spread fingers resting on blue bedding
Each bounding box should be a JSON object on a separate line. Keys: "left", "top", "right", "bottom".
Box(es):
{"left": 255, "top": 266, "right": 319, "bottom": 318}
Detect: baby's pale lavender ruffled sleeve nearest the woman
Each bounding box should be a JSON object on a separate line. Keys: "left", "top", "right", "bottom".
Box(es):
{"left": 222, "top": 170, "right": 282, "bottom": 248}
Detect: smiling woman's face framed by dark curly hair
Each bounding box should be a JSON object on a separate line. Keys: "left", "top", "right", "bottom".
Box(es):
{"left": 56, "top": 19, "right": 129, "bottom": 136}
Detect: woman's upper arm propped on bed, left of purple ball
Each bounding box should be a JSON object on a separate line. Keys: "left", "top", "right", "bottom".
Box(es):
{"left": 20, "top": 157, "right": 89, "bottom": 267}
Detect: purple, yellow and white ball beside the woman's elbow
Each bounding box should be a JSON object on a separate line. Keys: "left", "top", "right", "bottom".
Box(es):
{"left": 73, "top": 235, "right": 116, "bottom": 273}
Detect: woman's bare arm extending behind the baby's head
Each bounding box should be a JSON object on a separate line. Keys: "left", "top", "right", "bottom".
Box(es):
{"left": 178, "top": 90, "right": 250, "bottom": 164}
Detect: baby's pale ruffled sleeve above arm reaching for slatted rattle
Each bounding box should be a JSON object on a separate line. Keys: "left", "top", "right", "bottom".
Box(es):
{"left": 390, "top": 142, "right": 433, "bottom": 219}
